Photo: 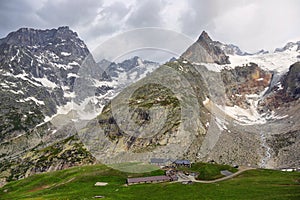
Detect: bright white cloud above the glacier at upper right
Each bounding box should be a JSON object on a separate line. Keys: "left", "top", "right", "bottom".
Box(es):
{"left": 212, "top": 0, "right": 300, "bottom": 52}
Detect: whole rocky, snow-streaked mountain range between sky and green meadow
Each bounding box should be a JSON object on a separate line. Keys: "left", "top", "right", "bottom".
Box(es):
{"left": 0, "top": 27, "right": 300, "bottom": 186}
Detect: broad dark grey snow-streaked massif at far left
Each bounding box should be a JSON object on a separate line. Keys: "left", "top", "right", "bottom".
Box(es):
{"left": 0, "top": 27, "right": 89, "bottom": 138}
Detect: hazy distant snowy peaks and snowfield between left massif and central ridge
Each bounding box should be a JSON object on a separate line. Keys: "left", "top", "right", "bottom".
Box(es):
{"left": 49, "top": 57, "right": 159, "bottom": 125}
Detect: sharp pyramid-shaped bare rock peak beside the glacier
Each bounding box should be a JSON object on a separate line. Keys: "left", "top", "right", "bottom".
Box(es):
{"left": 181, "top": 31, "right": 230, "bottom": 65}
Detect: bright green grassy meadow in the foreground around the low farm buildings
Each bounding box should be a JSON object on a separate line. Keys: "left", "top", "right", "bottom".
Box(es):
{"left": 0, "top": 165, "right": 300, "bottom": 200}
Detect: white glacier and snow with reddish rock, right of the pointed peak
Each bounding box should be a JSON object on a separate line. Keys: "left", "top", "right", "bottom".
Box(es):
{"left": 185, "top": 34, "right": 300, "bottom": 124}
